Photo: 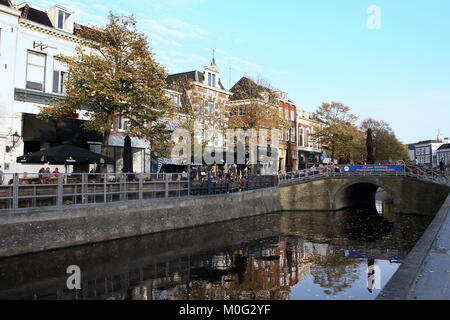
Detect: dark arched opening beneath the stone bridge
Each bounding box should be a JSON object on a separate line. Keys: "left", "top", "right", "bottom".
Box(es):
{"left": 331, "top": 177, "right": 400, "bottom": 210}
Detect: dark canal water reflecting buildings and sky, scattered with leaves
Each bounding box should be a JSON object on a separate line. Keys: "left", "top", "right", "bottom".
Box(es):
{"left": 0, "top": 203, "right": 432, "bottom": 300}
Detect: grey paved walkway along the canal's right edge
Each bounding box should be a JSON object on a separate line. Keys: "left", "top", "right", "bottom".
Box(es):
{"left": 377, "top": 195, "right": 450, "bottom": 300}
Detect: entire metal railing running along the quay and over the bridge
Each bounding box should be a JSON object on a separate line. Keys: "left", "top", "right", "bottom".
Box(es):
{"left": 0, "top": 168, "right": 450, "bottom": 212}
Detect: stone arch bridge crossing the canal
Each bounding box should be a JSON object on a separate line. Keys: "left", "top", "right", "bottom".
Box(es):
{"left": 279, "top": 175, "right": 450, "bottom": 215}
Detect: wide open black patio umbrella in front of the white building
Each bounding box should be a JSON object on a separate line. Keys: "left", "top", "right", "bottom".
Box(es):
{"left": 16, "top": 144, "right": 114, "bottom": 165}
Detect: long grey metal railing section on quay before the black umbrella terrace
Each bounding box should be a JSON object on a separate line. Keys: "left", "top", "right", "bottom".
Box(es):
{"left": 0, "top": 173, "right": 189, "bottom": 210}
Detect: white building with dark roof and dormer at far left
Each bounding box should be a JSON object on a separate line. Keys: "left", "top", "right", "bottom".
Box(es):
{"left": 0, "top": 0, "right": 150, "bottom": 178}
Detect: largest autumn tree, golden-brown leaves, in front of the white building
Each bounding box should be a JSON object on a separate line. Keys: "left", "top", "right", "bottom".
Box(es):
{"left": 39, "top": 13, "right": 173, "bottom": 159}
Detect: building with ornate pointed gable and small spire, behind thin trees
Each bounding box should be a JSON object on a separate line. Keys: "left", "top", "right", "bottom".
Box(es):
{"left": 162, "top": 59, "right": 232, "bottom": 172}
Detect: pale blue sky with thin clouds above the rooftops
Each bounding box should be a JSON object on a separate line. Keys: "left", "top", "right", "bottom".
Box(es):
{"left": 32, "top": 0, "right": 450, "bottom": 143}
